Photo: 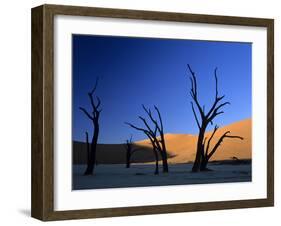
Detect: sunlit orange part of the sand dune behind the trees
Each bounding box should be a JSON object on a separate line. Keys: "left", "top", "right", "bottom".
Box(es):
{"left": 136, "top": 119, "right": 252, "bottom": 163}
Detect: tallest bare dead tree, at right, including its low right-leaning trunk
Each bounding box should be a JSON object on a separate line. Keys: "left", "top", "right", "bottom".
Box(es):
{"left": 188, "top": 64, "right": 243, "bottom": 172}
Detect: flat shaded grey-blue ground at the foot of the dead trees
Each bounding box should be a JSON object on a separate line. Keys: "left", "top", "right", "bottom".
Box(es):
{"left": 72, "top": 160, "right": 249, "bottom": 190}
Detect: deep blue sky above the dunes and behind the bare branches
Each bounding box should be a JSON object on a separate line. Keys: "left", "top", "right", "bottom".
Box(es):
{"left": 72, "top": 35, "right": 252, "bottom": 143}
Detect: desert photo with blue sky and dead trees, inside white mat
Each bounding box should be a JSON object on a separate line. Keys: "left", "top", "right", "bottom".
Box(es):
{"left": 72, "top": 34, "right": 252, "bottom": 190}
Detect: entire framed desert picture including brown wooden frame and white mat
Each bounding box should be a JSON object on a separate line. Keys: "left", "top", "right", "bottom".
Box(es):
{"left": 31, "top": 5, "right": 274, "bottom": 221}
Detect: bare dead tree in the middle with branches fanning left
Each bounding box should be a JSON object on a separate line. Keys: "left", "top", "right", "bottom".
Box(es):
{"left": 126, "top": 105, "right": 169, "bottom": 173}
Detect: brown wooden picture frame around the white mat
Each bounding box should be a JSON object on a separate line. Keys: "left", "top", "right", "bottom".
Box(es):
{"left": 31, "top": 5, "right": 274, "bottom": 221}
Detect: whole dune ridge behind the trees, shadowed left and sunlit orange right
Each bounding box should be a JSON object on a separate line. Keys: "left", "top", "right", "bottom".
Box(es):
{"left": 73, "top": 119, "right": 249, "bottom": 164}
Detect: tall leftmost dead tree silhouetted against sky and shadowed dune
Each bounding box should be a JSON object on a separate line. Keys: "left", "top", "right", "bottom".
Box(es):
{"left": 80, "top": 79, "right": 101, "bottom": 175}
